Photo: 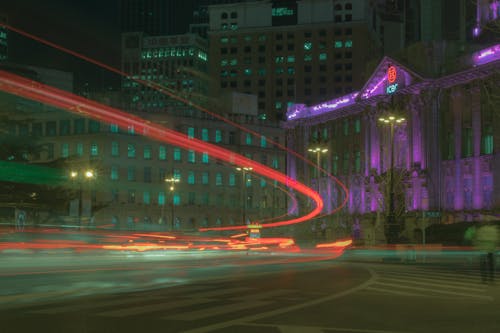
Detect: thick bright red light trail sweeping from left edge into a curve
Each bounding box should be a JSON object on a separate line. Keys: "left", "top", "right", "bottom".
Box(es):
{"left": 0, "top": 71, "right": 323, "bottom": 230}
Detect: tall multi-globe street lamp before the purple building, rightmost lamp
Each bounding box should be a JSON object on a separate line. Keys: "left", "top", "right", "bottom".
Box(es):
{"left": 378, "top": 115, "right": 405, "bottom": 244}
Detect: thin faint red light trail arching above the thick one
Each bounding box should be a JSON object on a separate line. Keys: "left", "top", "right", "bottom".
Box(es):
{"left": 0, "top": 23, "right": 349, "bottom": 230}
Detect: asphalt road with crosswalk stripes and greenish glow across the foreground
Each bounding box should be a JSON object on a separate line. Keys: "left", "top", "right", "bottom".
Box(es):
{"left": 0, "top": 252, "right": 500, "bottom": 333}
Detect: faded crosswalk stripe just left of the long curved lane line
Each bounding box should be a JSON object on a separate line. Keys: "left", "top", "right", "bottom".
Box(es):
{"left": 163, "top": 299, "right": 272, "bottom": 320}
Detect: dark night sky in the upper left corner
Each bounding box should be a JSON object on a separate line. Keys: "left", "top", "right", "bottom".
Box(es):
{"left": 0, "top": 0, "right": 120, "bottom": 86}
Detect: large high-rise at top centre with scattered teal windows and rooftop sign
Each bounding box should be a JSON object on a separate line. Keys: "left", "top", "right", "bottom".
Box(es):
{"left": 208, "top": 0, "right": 375, "bottom": 120}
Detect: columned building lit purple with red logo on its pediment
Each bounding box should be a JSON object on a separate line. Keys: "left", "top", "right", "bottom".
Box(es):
{"left": 285, "top": 45, "right": 500, "bottom": 244}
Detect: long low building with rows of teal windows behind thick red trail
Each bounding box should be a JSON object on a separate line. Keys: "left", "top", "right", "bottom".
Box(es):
{"left": 3, "top": 64, "right": 288, "bottom": 229}
